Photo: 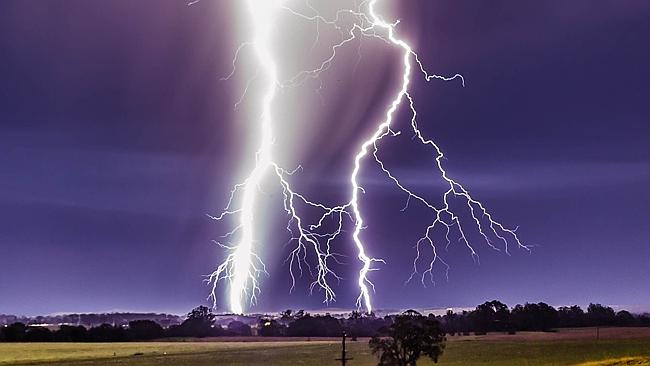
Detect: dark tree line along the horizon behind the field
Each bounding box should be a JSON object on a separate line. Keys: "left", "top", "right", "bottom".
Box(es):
{"left": 0, "top": 300, "right": 650, "bottom": 342}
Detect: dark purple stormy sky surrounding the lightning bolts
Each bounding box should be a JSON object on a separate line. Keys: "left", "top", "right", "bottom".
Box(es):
{"left": 0, "top": 0, "right": 650, "bottom": 314}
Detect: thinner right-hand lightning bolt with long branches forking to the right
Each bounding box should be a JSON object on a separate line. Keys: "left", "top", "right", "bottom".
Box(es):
{"left": 350, "top": 0, "right": 529, "bottom": 311}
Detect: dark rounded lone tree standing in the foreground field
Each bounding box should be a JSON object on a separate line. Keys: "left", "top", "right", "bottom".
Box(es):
{"left": 370, "top": 310, "right": 445, "bottom": 366}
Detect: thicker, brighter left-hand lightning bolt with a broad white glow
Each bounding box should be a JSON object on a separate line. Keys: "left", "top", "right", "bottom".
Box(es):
{"left": 208, "top": 0, "right": 350, "bottom": 314}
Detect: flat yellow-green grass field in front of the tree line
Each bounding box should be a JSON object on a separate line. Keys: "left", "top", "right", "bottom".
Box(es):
{"left": 0, "top": 328, "right": 650, "bottom": 366}
